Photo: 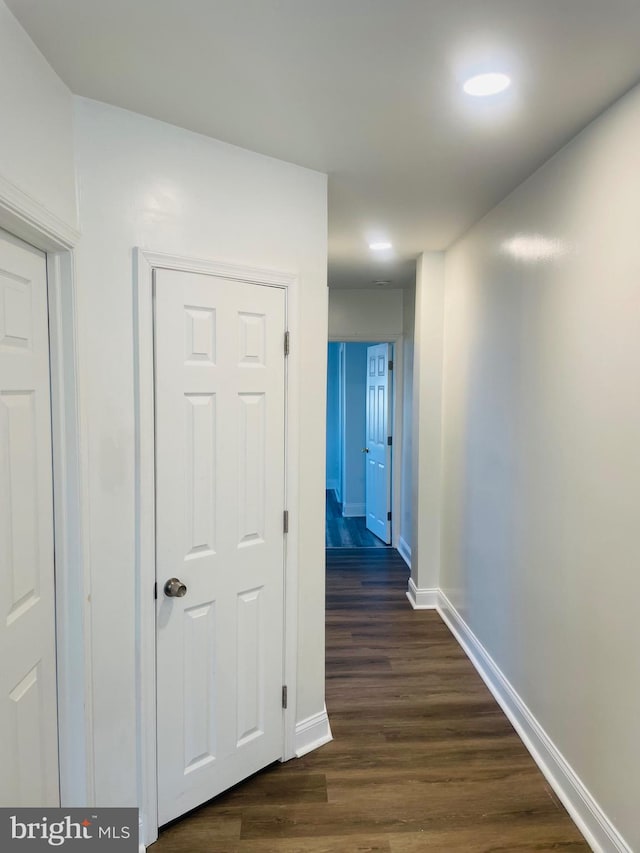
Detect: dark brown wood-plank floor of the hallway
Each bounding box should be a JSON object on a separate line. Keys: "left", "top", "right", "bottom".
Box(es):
{"left": 152, "top": 549, "right": 589, "bottom": 853}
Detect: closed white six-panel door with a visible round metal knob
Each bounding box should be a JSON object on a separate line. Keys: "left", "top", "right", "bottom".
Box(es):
{"left": 154, "top": 270, "right": 285, "bottom": 825}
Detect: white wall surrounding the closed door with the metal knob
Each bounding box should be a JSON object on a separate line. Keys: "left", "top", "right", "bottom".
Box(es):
{"left": 75, "top": 99, "right": 327, "bottom": 806}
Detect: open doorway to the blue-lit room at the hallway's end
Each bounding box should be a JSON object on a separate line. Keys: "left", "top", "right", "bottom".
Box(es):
{"left": 325, "top": 341, "right": 394, "bottom": 548}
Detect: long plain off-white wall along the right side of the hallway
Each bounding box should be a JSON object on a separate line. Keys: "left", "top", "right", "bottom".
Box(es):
{"left": 440, "top": 81, "right": 640, "bottom": 850}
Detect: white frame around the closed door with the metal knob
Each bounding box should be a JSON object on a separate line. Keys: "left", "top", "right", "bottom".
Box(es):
{"left": 134, "top": 248, "right": 299, "bottom": 845}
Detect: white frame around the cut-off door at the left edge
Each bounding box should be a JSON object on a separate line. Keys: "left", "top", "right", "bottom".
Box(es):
{"left": 0, "top": 177, "right": 94, "bottom": 807}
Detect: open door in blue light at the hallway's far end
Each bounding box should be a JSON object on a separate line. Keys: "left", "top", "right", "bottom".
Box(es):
{"left": 365, "top": 344, "right": 392, "bottom": 545}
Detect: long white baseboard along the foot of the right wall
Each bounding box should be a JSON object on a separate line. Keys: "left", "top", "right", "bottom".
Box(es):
{"left": 438, "top": 581, "right": 632, "bottom": 853}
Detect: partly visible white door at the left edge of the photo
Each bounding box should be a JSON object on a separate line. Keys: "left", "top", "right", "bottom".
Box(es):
{"left": 0, "top": 226, "right": 59, "bottom": 806}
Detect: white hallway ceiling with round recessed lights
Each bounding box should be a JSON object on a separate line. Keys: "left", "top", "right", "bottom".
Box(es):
{"left": 6, "top": 0, "right": 640, "bottom": 287}
